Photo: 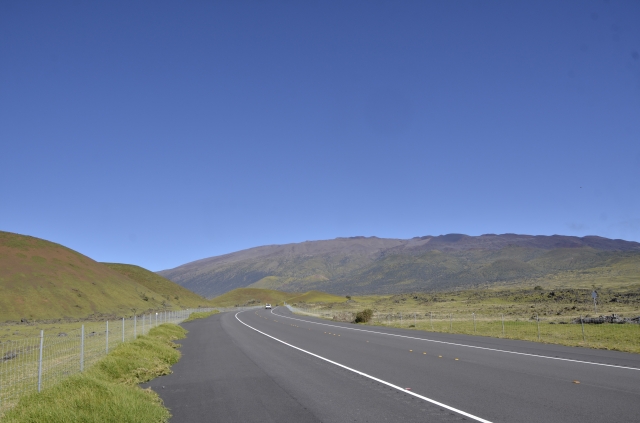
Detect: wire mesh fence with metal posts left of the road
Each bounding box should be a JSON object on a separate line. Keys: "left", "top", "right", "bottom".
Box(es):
{"left": 0, "top": 308, "right": 255, "bottom": 416}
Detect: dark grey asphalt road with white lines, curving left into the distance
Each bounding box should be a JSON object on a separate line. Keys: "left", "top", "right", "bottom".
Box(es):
{"left": 145, "top": 307, "right": 640, "bottom": 423}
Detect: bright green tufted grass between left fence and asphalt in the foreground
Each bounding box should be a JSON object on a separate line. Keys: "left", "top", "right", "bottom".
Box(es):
{"left": 2, "top": 324, "right": 186, "bottom": 423}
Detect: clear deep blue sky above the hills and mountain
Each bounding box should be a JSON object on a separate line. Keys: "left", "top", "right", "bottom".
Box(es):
{"left": 0, "top": 0, "right": 640, "bottom": 270}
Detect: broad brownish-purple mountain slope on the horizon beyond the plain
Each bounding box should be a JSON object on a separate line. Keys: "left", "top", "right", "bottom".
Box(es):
{"left": 159, "top": 234, "right": 640, "bottom": 297}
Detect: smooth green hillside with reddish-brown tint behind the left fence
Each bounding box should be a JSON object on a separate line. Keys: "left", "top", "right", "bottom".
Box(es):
{"left": 0, "top": 231, "right": 210, "bottom": 322}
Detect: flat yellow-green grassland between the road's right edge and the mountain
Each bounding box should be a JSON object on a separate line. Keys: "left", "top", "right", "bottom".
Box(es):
{"left": 292, "top": 285, "right": 640, "bottom": 353}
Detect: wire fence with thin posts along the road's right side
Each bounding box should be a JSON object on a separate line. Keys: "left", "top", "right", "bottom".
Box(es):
{"left": 287, "top": 306, "right": 640, "bottom": 353}
